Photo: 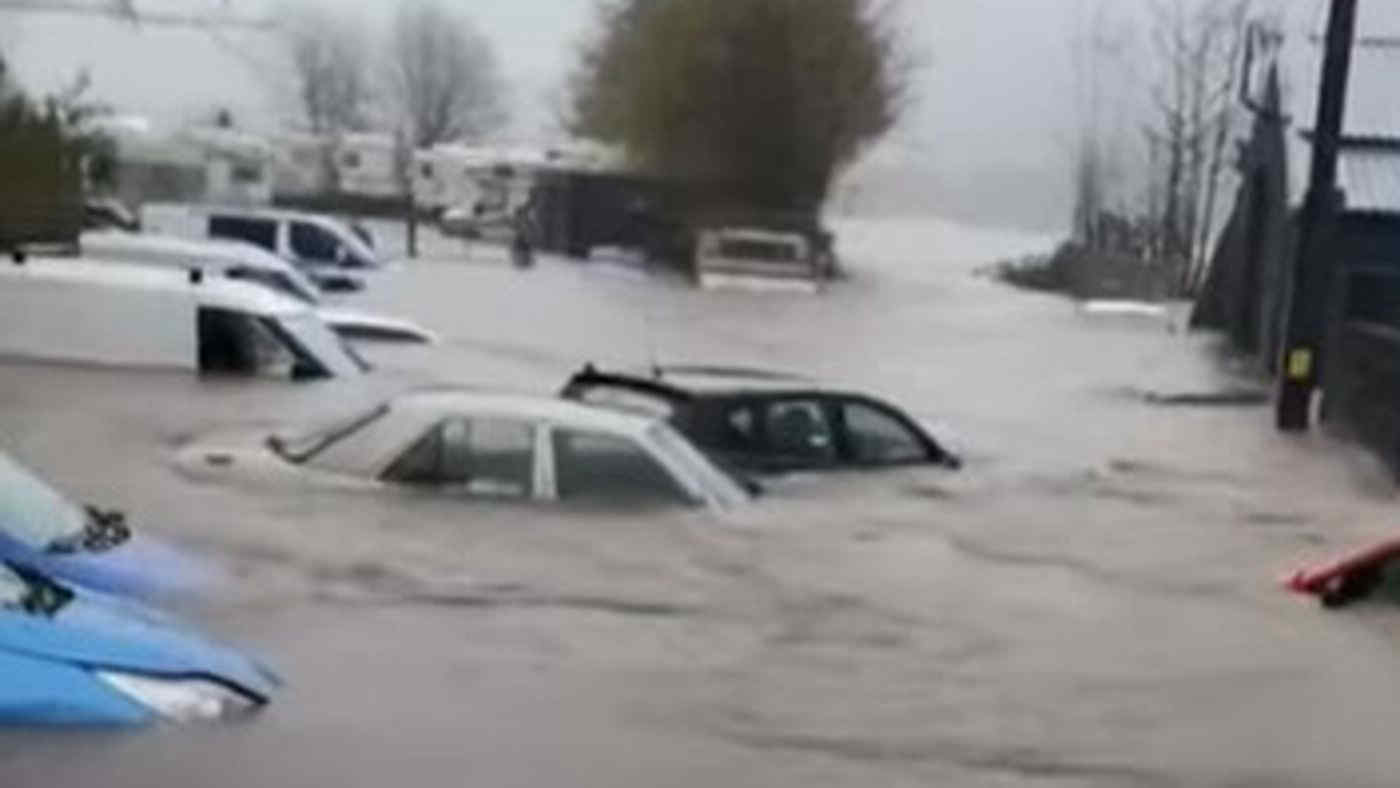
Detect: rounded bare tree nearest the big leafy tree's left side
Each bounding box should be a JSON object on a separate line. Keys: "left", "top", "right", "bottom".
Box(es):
{"left": 389, "top": 0, "right": 505, "bottom": 148}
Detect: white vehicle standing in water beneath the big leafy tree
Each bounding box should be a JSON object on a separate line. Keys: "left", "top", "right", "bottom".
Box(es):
{"left": 696, "top": 227, "right": 825, "bottom": 293}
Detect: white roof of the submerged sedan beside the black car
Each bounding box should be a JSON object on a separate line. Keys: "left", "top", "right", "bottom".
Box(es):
{"left": 389, "top": 389, "right": 658, "bottom": 438}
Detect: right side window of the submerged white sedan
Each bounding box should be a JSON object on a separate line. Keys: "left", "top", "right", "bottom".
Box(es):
{"left": 553, "top": 430, "right": 693, "bottom": 504}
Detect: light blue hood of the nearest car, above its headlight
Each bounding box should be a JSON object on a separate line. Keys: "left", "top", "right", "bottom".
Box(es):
{"left": 0, "top": 589, "right": 281, "bottom": 700}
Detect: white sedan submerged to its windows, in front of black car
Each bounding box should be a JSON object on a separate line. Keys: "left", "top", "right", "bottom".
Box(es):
{"left": 176, "top": 389, "right": 749, "bottom": 509}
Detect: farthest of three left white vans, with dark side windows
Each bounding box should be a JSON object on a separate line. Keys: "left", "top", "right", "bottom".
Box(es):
{"left": 141, "top": 203, "right": 384, "bottom": 270}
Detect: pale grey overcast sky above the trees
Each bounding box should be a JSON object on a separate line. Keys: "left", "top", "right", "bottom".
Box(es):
{"left": 0, "top": 0, "right": 1366, "bottom": 225}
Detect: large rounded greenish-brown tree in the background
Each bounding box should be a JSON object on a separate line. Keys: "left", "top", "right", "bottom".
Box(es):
{"left": 570, "top": 0, "right": 909, "bottom": 211}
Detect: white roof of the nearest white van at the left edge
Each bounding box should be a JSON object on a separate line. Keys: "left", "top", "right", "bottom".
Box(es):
{"left": 0, "top": 258, "right": 309, "bottom": 315}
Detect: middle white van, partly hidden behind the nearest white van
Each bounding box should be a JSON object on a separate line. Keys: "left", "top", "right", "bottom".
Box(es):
{"left": 78, "top": 231, "right": 437, "bottom": 343}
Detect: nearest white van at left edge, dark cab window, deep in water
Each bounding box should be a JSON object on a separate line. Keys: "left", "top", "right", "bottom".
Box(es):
{"left": 0, "top": 258, "right": 368, "bottom": 381}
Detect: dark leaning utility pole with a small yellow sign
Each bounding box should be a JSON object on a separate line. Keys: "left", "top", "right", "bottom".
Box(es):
{"left": 1277, "top": 0, "right": 1357, "bottom": 432}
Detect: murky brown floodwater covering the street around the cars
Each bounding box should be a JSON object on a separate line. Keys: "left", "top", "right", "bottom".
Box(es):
{"left": 0, "top": 223, "right": 1400, "bottom": 788}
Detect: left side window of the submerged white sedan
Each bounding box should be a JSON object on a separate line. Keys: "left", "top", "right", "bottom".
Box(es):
{"left": 384, "top": 418, "right": 535, "bottom": 498}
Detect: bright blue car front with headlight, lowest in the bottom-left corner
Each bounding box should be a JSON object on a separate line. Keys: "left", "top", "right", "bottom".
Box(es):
{"left": 0, "top": 561, "right": 280, "bottom": 726}
